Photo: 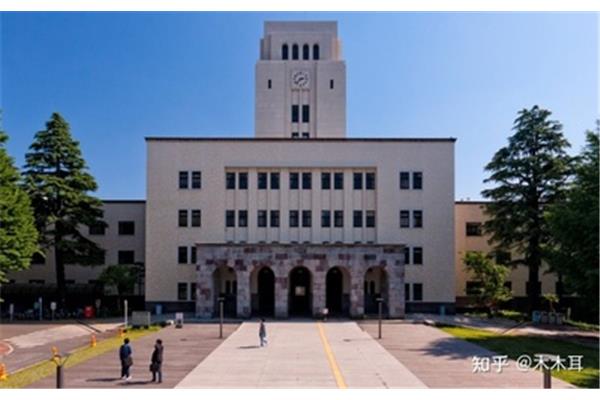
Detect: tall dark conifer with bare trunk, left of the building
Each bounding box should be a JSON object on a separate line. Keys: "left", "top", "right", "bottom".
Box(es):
{"left": 24, "top": 113, "right": 104, "bottom": 307}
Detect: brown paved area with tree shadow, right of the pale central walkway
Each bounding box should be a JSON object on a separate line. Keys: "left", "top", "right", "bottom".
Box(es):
{"left": 361, "top": 322, "right": 572, "bottom": 388}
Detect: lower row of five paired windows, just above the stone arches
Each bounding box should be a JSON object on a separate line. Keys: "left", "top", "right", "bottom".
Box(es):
{"left": 225, "top": 210, "right": 375, "bottom": 228}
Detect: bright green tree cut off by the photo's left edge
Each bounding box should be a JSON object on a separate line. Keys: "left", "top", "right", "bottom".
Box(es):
{"left": 0, "top": 119, "right": 38, "bottom": 283}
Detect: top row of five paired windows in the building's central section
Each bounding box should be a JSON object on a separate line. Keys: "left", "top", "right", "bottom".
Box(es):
{"left": 225, "top": 172, "right": 375, "bottom": 190}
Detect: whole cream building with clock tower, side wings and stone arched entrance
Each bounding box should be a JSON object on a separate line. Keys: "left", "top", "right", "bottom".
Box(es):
{"left": 3, "top": 22, "right": 552, "bottom": 318}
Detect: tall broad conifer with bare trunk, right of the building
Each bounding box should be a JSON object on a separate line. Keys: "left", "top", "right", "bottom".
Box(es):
{"left": 482, "top": 106, "right": 571, "bottom": 311}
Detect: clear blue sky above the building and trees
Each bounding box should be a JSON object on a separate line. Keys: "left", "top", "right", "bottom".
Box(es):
{"left": 0, "top": 12, "right": 599, "bottom": 199}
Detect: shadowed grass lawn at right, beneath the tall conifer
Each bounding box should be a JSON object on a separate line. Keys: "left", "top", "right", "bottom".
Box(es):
{"left": 440, "top": 326, "right": 600, "bottom": 388}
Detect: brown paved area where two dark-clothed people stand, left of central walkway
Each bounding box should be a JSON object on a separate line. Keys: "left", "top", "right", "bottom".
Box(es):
{"left": 29, "top": 323, "right": 239, "bottom": 389}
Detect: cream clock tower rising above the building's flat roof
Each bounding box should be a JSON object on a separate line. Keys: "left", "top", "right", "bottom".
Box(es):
{"left": 254, "top": 21, "right": 346, "bottom": 139}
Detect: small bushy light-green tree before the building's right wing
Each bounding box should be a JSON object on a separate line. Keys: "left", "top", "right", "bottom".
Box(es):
{"left": 463, "top": 251, "right": 511, "bottom": 316}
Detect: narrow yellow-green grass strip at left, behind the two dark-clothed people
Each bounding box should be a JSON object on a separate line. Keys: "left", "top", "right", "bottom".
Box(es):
{"left": 0, "top": 326, "right": 161, "bottom": 388}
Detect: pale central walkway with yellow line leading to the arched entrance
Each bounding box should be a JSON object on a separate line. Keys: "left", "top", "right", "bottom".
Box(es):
{"left": 177, "top": 321, "right": 425, "bottom": 388}
